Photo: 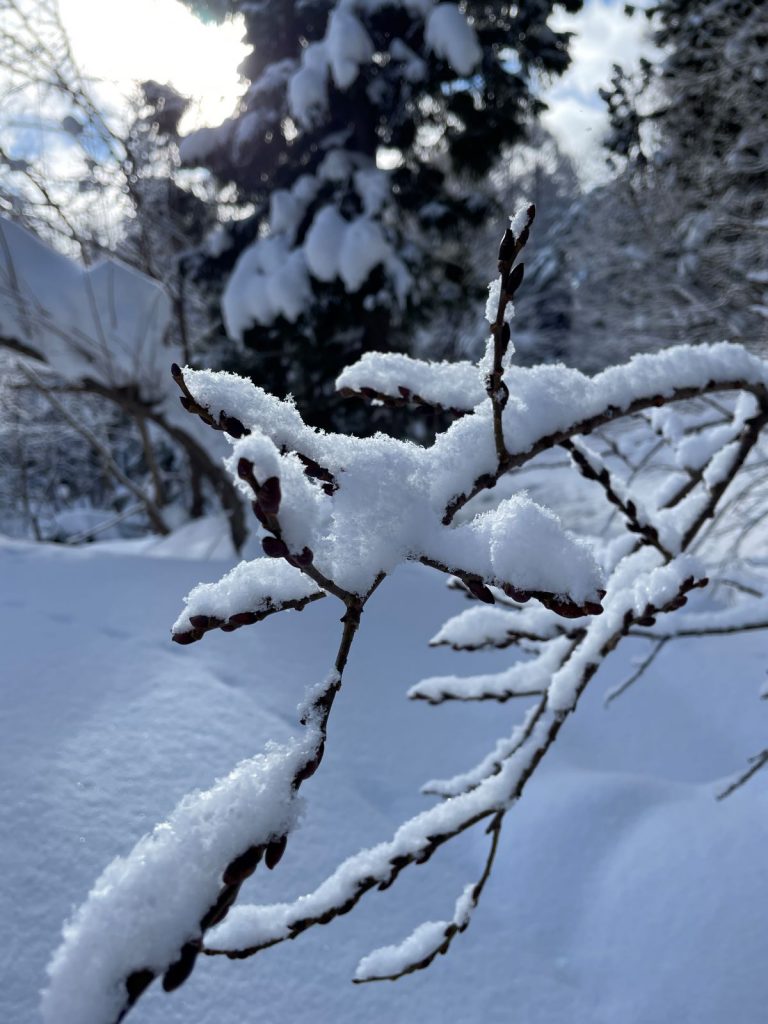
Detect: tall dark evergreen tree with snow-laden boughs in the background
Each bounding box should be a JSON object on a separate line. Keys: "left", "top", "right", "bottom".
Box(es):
{"left": 181, "top": 0, "right": 582, "bottom": 426}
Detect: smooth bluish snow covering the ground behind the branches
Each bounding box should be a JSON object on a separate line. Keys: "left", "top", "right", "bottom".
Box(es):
{"left": 0, "top": 526, "right": 768, "bottom": 1024}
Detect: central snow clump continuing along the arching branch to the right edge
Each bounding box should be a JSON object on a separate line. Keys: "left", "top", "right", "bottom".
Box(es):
{"left": 177, "top": 344, "right": 766, "bottom": 601}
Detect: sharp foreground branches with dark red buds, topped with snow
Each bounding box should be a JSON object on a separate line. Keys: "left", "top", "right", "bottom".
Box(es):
{"left": 43, "top": 208, "right": 768, "bottom": 1024}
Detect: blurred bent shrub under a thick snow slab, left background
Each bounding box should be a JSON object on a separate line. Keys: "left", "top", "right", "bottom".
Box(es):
{"left": 0, "top": 218, "right": 246, "bottom": 547}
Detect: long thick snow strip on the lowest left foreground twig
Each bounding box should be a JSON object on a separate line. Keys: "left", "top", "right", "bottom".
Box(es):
{"left": 42, "top": 736, "right": 310, "bottom": 1024}
